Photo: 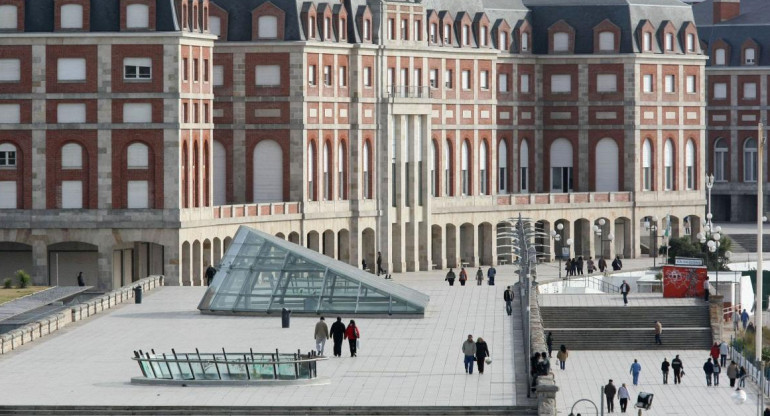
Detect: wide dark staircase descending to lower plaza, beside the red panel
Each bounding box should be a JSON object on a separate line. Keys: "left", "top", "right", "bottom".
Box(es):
{"left": 540, "top": 303, "right": 712, "bottom": 350}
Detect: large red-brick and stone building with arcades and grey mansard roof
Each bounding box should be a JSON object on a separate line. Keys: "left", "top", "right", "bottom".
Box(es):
{"left": 0, "top": 0, "right": 706, "bottom": 287}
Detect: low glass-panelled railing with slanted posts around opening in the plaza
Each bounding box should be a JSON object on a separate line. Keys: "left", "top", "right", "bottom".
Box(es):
{"left": 131, "top": 348, "right": 326, "bottom": 380}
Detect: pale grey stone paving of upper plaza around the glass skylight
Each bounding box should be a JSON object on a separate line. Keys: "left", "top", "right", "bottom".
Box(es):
{"left": 0, "top": 271, "right": 524, "bottom": 406}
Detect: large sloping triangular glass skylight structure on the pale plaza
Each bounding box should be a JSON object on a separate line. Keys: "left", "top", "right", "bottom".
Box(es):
{"left": 198, "top": 226, "right": 430, "bottom": 317}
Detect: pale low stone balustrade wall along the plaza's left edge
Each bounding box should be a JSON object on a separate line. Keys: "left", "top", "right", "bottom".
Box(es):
{"left": 0, "top": 276, "right": 164, "bottom": 354}
